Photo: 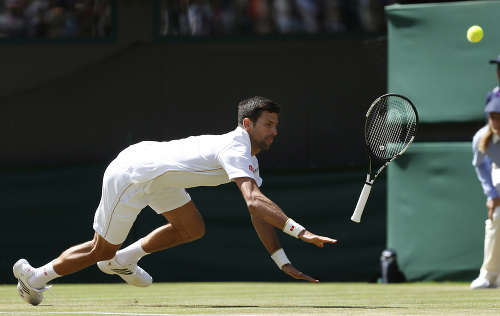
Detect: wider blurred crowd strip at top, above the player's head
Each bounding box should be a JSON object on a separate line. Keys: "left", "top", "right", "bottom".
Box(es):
{"left": 160, "top": 0, "right": 393, "bottom": 35}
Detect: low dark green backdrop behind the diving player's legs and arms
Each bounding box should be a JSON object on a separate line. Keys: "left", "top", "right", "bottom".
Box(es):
{"left": 0, "top": 164, "right": 386, "bottom": 283}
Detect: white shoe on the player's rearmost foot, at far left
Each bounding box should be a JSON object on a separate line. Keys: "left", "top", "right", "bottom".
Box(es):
{"left": 12, "top": 259, "right": 47, "bottom": 305}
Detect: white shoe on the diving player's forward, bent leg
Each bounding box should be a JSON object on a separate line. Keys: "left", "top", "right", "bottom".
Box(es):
{"left": 97, "top": 258, "right": 153, "bottom": 287}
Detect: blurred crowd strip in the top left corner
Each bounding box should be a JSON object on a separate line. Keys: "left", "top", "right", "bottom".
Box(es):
{"left": 0, "top": 0, "right": 111, "bottom": 38}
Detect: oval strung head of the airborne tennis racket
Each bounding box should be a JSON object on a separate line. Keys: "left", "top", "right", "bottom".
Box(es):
{"left": 365, "top": 96, "right": 417, "bottom": 160}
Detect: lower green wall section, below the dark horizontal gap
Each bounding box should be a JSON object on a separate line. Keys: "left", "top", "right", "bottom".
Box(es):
{"left": 387, "top": 143, "right": 487, "bottom": 280}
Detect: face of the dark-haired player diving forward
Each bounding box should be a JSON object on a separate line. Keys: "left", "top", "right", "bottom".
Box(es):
{"left": 246, "top": 111, "right": 278, "bottom": 155}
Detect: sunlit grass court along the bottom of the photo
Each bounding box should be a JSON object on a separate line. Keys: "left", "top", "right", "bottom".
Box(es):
{"left": 0, "top": 282, "right": 500, "bottom": 316}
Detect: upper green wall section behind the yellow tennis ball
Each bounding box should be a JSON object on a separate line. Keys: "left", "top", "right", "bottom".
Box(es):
{"left": 386, "top": 1, "right": 500, "bottom": 123}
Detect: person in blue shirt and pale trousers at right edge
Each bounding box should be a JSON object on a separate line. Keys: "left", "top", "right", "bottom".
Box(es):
{"left": 470, "top": 96, "right": 500, "bottom": 290}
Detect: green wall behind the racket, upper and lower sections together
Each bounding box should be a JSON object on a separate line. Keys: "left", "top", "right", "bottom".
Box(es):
{"left": 386, "top": 1, "right": 500, "bottom": 280}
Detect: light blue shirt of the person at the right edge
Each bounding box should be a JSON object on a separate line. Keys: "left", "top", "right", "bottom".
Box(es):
{"left": 472, "top": 125, "right": 500, "bottom": 200}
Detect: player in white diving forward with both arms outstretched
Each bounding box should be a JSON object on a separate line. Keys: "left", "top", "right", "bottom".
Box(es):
{"left": 13, "top": 97, "right": 336, "bottom": 305}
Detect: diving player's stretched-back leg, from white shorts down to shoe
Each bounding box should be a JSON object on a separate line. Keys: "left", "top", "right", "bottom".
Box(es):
{"left": 13, "top": 160, "right": 147, "bottom": 305}
